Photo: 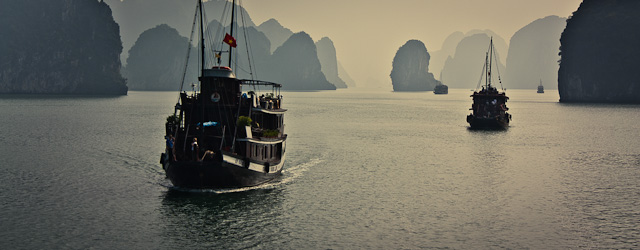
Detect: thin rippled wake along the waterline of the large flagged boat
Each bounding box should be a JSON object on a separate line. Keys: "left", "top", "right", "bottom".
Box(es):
{"left": 160, "top": 159, "right": 322, "bottom": 194}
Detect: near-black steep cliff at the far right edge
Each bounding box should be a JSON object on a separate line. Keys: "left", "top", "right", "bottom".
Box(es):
{"left": 558, "top": 0, "right": 640, "bottom": 103}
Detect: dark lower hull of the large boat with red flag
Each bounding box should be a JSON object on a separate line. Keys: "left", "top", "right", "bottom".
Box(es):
{"left": 163, "top": 155, "right": 282, "bottom": 189}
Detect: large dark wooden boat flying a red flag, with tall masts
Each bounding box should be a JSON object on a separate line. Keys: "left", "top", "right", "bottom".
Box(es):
{"left": 161, "top": 0, "right": 287, "bottom": 189}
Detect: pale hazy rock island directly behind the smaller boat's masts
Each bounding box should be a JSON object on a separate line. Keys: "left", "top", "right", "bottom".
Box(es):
{"left": 442, "top": 33, "right": 509, "bottom": 89}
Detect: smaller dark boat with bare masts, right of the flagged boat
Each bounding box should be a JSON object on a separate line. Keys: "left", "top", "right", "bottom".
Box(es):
{"left": 467, "top": 38, "right": 511, "bottom": 129}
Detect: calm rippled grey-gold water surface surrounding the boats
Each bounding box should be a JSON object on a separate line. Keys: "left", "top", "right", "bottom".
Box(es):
{"left": 0, "top": 89, "right": 640, "bottom": 249}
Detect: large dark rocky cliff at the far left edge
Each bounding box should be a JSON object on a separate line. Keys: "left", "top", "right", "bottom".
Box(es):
{"left": 0, "top": 0, "right": 127, "bottom": 95}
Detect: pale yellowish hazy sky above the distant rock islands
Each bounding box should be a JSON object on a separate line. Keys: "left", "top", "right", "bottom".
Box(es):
{"left": 241, "top": 0, "right": 582, "bottom": 89}
